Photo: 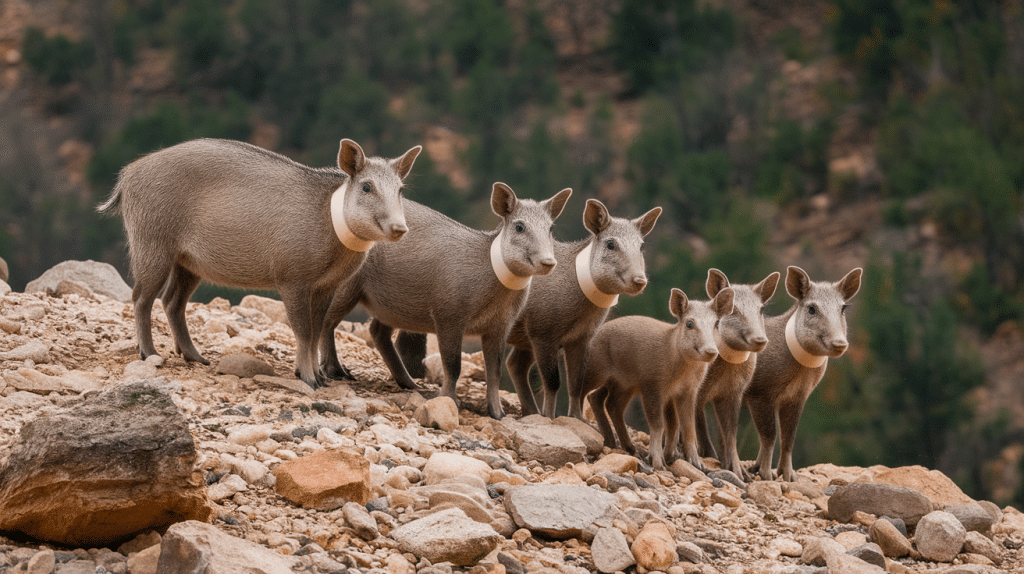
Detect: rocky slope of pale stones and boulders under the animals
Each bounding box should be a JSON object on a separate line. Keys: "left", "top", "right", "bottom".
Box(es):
{"left": 0, "top": 260, "right": 1024, "bottom": 574}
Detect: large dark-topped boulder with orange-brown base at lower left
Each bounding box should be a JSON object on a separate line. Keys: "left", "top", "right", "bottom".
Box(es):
{"left": 0, "top": 382, "right": 211, "bottom": 546}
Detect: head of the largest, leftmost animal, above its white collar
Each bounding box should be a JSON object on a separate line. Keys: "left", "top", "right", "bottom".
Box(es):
{"left": 338, "top": 139, "right": 423, "bottom": 246}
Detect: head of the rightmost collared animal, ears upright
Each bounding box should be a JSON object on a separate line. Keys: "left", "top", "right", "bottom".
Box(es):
{"left": 785, "top": 267, "right": 862, "bottom": 358}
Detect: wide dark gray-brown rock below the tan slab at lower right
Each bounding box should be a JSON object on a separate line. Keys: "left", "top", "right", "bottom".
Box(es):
{"left": 828, "top": 483, "right": 932, "bottom": 526}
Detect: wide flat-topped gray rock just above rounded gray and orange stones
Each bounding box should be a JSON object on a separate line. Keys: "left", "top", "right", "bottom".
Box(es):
{"left": 505, "top": 484, "right": 616, "bottom": 538}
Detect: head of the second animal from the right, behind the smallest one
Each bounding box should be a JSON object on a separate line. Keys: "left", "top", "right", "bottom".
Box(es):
{"left": 707, "top": 269, "right": 781, "bottom": 353}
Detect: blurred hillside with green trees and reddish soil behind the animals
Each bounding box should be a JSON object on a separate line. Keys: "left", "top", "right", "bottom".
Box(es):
{"left": 0, "top": 0, "right": 1024, "bottom": 506}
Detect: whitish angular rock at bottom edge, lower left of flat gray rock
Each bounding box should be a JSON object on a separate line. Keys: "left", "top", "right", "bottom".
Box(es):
{"left": 391, "top": 509, "right": 502, "bottom": 566}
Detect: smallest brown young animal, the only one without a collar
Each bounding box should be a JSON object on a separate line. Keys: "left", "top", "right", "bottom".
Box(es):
{"left": 583, "top": 288, "right": 733, "bottom": 470}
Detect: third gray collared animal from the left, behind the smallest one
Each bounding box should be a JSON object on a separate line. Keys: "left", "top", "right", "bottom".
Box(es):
{"left": 506, "top": 200, "right": 662, "bottom": 418}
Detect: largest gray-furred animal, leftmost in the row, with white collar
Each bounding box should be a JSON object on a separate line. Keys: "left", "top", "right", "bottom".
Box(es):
{"left": 97, "top": 139, "right": 421, "bottom": 388}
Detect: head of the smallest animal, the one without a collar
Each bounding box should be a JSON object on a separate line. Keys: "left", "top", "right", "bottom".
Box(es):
{"left": 669, "top": 288, "right": 733, "bottom": 362}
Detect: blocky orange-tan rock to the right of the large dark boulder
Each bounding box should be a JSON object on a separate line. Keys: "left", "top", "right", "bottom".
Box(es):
{"left": 273, "top": 449, "right": 371, "bottom": 511}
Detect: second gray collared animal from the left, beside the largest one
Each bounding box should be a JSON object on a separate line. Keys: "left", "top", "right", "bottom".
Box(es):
{"left": 321, "top": 183, "right": 572, "bottom": 418}
